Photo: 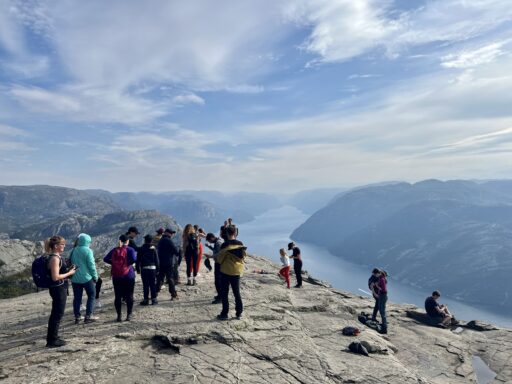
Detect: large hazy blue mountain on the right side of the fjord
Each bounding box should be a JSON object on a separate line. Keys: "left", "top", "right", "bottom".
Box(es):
{"left": 291, "top": 180, "right": 512, "bottom": 314}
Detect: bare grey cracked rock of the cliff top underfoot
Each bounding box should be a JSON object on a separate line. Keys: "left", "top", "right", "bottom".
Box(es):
{"left": 0, "top": 257, "right": 512, "bottom": 384}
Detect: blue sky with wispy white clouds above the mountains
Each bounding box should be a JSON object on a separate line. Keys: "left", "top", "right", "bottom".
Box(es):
{"left": 0, "top": 0, "right": 512, "bottom": 192}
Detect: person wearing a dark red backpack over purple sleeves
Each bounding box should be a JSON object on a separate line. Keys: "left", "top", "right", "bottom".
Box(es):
{"left": 103, "top": 235, "right": 137, "bottom": 322}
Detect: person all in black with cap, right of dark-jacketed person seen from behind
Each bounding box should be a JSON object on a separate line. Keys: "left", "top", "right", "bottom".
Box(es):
{"left": 157, "top": 228, "right": 179, "bottom": 300}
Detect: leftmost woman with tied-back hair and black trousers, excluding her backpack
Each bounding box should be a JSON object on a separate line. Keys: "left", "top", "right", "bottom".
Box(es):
{"left": 44, "top": 236, "right": 76, "bottom": 348}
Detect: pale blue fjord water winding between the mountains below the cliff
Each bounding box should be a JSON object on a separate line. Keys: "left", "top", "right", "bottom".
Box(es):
{"left": 239, "top": 206, "right": 512, "bottom": 328}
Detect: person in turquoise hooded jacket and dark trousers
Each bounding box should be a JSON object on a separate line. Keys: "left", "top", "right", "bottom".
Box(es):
{"left": 69, "top": 233, "right": 98, "bottom": 324}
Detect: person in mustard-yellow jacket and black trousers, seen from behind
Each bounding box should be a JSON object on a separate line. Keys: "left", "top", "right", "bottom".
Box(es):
{"left": 216, "top": 225, "right": 247, "bottom": 320}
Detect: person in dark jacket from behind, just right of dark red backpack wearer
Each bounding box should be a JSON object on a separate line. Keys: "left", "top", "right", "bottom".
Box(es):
{"left": 135, "top": 235, "right": 160, "bottom": 305}
